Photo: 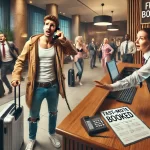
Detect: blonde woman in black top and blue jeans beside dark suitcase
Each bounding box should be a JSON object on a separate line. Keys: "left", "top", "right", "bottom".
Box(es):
{"left": 74, "top": 36, "right": 88, "bottom": 85}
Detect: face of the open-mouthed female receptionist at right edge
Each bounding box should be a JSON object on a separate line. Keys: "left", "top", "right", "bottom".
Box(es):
{"left": 135, "top": 30, "right": 150, "bottom": 53}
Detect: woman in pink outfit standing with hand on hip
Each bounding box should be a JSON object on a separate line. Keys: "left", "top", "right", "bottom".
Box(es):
{"left": 101, "top": 38, "right": 114, "bottom": 73}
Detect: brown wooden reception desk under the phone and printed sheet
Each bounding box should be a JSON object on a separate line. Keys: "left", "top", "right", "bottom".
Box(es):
{"left": 56, "top": 63, "right": 150, "bottom": 150}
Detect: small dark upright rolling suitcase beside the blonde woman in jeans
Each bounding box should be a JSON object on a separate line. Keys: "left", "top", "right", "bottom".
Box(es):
{"left": 68, "top": 62, "right": 75, "bottom": 87}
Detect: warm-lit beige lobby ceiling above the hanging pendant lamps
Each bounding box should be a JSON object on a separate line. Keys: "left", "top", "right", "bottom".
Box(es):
{"left": 29, "top": 0, "right": 127, "bottom": 22}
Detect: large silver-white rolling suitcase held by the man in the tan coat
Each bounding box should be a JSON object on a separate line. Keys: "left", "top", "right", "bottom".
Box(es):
{"left": 0, "top": 86, "right": 24, "bottom": 150}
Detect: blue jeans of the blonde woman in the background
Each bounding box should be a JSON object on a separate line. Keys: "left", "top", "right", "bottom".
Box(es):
{"left": 75, "top": 58, "right": 84, "bottom": 81}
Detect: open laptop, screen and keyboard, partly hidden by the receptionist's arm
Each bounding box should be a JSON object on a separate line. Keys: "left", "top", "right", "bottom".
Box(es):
{"left": 106, "top": 60, "right": 137, "bottom": 104}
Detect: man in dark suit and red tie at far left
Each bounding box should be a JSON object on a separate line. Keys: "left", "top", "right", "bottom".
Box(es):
{"left": 0, "top": 33, "right": 19, "bottom": 94}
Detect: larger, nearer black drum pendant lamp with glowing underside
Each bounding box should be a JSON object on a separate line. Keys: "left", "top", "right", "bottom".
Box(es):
{"left": 93, "top": 3, "right": 112, "bottom": 26}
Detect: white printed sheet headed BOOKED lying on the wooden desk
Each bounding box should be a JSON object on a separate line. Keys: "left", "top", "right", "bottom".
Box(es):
{"left": 101, "top": 107, "right": 150, "bottom": 146}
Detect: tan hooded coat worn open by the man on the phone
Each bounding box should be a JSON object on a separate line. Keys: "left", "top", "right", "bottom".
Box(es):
{"left": 12, "top": 34, "right": 77, "bottom": 108}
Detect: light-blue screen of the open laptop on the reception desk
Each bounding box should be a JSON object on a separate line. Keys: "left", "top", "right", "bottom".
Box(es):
{"left": 106, "top": 60, "right": 119, "bottom": 83}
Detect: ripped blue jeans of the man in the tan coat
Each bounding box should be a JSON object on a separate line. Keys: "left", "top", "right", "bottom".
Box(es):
{"left": 28, "top": 83, "right": 59, "bottom": 140}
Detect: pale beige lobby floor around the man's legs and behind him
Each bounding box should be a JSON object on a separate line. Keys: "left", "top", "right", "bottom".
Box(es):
{"left": 0, "top": 59, "right": 104, "bottom": 150}
